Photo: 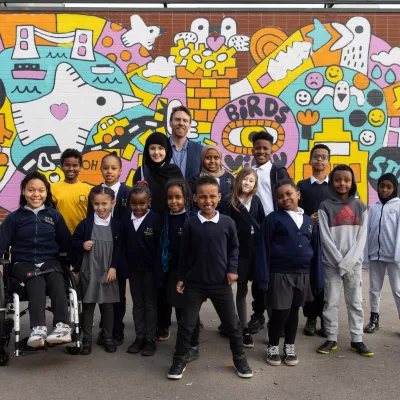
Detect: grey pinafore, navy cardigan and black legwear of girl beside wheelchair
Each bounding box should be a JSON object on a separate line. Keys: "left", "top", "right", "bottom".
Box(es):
{"left": 72, "top": 214, "right": 120, "bottom": 342}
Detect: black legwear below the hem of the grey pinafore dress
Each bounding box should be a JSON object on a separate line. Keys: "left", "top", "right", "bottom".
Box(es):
{"left": 82, "top": 303, "right": 114, "bottom": 342}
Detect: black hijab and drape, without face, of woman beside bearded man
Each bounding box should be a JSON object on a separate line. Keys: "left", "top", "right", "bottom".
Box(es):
{"left": 143, "top": 132, "right": 184, "bottom": 214}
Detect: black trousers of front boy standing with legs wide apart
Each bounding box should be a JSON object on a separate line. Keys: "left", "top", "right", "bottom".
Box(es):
{"left": 175, "top": 286, "right": 244, "bottom": 357}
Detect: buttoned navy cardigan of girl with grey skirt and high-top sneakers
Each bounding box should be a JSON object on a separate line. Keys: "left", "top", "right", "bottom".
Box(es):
{"left": 256, "top": 210, "right": 324, "bottom": 289}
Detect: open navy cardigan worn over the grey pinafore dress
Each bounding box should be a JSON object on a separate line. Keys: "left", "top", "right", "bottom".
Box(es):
{"left": 71, "top": 213, "right": 120, "bottom": 272}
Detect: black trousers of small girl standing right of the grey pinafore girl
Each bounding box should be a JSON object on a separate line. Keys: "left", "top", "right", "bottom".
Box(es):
{"left": 129, "top": 271, "right": 157, "bottom": 341}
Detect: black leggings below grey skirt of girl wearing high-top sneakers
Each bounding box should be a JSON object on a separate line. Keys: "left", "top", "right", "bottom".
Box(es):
{"left": 268, "top": 306, "right": 300, "bottom": 346}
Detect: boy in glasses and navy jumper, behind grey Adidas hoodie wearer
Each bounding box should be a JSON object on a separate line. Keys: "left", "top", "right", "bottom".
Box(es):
{"left": 297, "top": 144, "right": 330, "bottom": 337}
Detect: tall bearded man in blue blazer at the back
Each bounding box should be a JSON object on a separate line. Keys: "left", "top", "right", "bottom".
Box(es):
{"left": 169, "top": 106, "right": 202, "bottom": 182}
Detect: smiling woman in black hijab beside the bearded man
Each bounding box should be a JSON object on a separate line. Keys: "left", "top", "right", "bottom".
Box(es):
{"left": 133, "top": 132, "right": 184, "bottom": 217}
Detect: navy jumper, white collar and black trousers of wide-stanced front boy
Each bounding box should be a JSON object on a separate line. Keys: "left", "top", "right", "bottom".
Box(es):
{"left": 175, "top": 212, "right": 244, "bottom": 357}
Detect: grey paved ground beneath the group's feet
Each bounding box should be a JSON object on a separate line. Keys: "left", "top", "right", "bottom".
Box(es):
{"left": 0, "top": 272, "right": 400, "bottom": 400}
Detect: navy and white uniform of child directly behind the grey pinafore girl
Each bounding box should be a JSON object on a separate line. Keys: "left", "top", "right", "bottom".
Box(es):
{"left": 87, "top": 182, "right": 131, "bottom": 336}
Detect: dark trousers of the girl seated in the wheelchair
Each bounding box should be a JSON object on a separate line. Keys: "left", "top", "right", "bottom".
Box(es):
{"left": 11, "top": 260, "right": 69, "bottom": 328}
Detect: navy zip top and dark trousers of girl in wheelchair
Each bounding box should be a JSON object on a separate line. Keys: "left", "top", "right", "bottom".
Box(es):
{"left": 0, "top": 203, "right": 71, "bottom": 327}
